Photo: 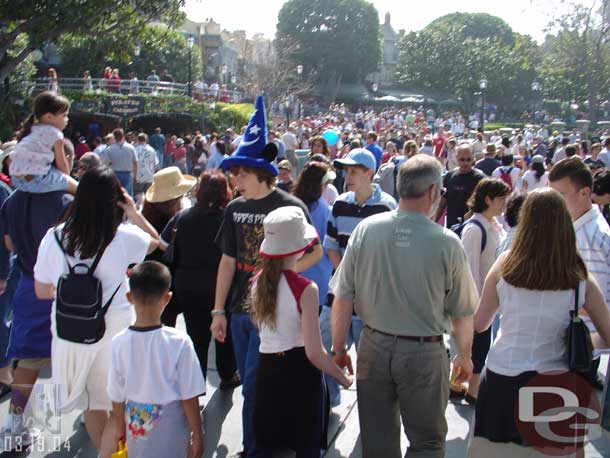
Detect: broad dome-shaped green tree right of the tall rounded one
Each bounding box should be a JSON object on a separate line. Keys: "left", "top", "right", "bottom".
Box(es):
{"left": 398, "top": 13, "right": 539, "bottom": 114}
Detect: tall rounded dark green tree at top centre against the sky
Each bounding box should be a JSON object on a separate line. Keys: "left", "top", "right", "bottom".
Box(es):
{"left": 276, "top": 0, "right": 381, "bottom": 98}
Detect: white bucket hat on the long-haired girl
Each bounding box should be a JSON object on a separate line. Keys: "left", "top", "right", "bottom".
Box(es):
{"left": 260, "top": 206, "right": 318, "bottom": 258}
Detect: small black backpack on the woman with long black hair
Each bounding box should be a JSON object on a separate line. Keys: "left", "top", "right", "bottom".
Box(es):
{"left": 53, "top": 231, "right": 122, "bottom": 344}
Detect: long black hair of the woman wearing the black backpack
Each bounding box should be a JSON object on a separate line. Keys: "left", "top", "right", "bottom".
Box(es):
{"left": 63, "top": 167, "right": 125, "bottom": 259}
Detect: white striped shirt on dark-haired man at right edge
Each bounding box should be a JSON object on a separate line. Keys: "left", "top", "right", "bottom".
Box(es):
{"left": 574, "top": 205, "right": 610, "bottom": 328}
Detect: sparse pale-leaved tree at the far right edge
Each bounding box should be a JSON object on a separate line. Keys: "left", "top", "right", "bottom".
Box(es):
{"left": 539, "top": 0, "right": 610, "bottom": 121}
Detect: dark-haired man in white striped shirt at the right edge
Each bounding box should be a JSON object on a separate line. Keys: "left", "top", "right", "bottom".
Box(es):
{"left": 549, "top": 157, "right": 610, "bottom": 390}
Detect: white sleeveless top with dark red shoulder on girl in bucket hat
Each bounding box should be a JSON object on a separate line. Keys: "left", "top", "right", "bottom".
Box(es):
{"left": 253, "top": 270, "right": 311, "bottom": 353}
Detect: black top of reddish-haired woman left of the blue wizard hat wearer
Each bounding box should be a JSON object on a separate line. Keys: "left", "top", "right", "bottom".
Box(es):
{"left": 161, "top": 207, "right": 222, "bottom": 296}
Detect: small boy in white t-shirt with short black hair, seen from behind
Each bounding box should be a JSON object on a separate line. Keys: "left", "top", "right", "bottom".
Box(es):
{"left": 107, "top": 261, "right": 205, "bottom": 458}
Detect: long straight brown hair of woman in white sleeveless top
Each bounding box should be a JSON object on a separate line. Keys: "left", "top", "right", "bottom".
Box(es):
{"left": 501, "top": 188, "right": 588, "bottom": 291}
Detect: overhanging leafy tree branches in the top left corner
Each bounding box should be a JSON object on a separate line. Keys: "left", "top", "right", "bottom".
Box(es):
{"left": 0, "top": 0, "right": 184, "bottom": 81}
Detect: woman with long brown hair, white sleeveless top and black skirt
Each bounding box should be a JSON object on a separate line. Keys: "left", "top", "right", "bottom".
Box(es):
{"left": 469, "top": 188, "right": 610, "bottom": 457}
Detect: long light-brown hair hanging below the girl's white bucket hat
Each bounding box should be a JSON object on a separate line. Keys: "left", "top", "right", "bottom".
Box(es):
{"left": 247, "top": 258, "right": 284, "bottom": 329}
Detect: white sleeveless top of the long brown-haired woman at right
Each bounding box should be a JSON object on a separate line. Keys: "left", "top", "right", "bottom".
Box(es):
{"left": 486, "top": 279, "right": 586, "bottom": 377}
